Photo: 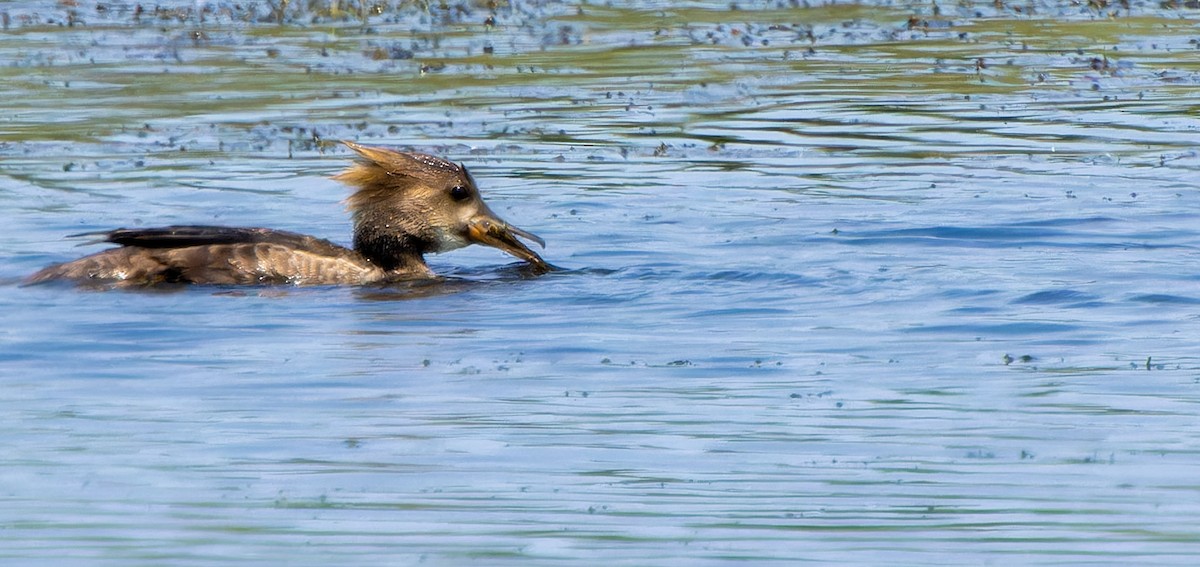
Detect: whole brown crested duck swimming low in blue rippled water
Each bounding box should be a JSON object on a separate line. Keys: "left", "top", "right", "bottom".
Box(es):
{"left": 26, "top": 142, "right": 553, "bottom": 287}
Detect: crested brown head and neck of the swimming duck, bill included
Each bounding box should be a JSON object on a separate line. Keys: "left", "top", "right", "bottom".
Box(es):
{"left": 334, "top": 142, "right": 553, "bottom": 271}
